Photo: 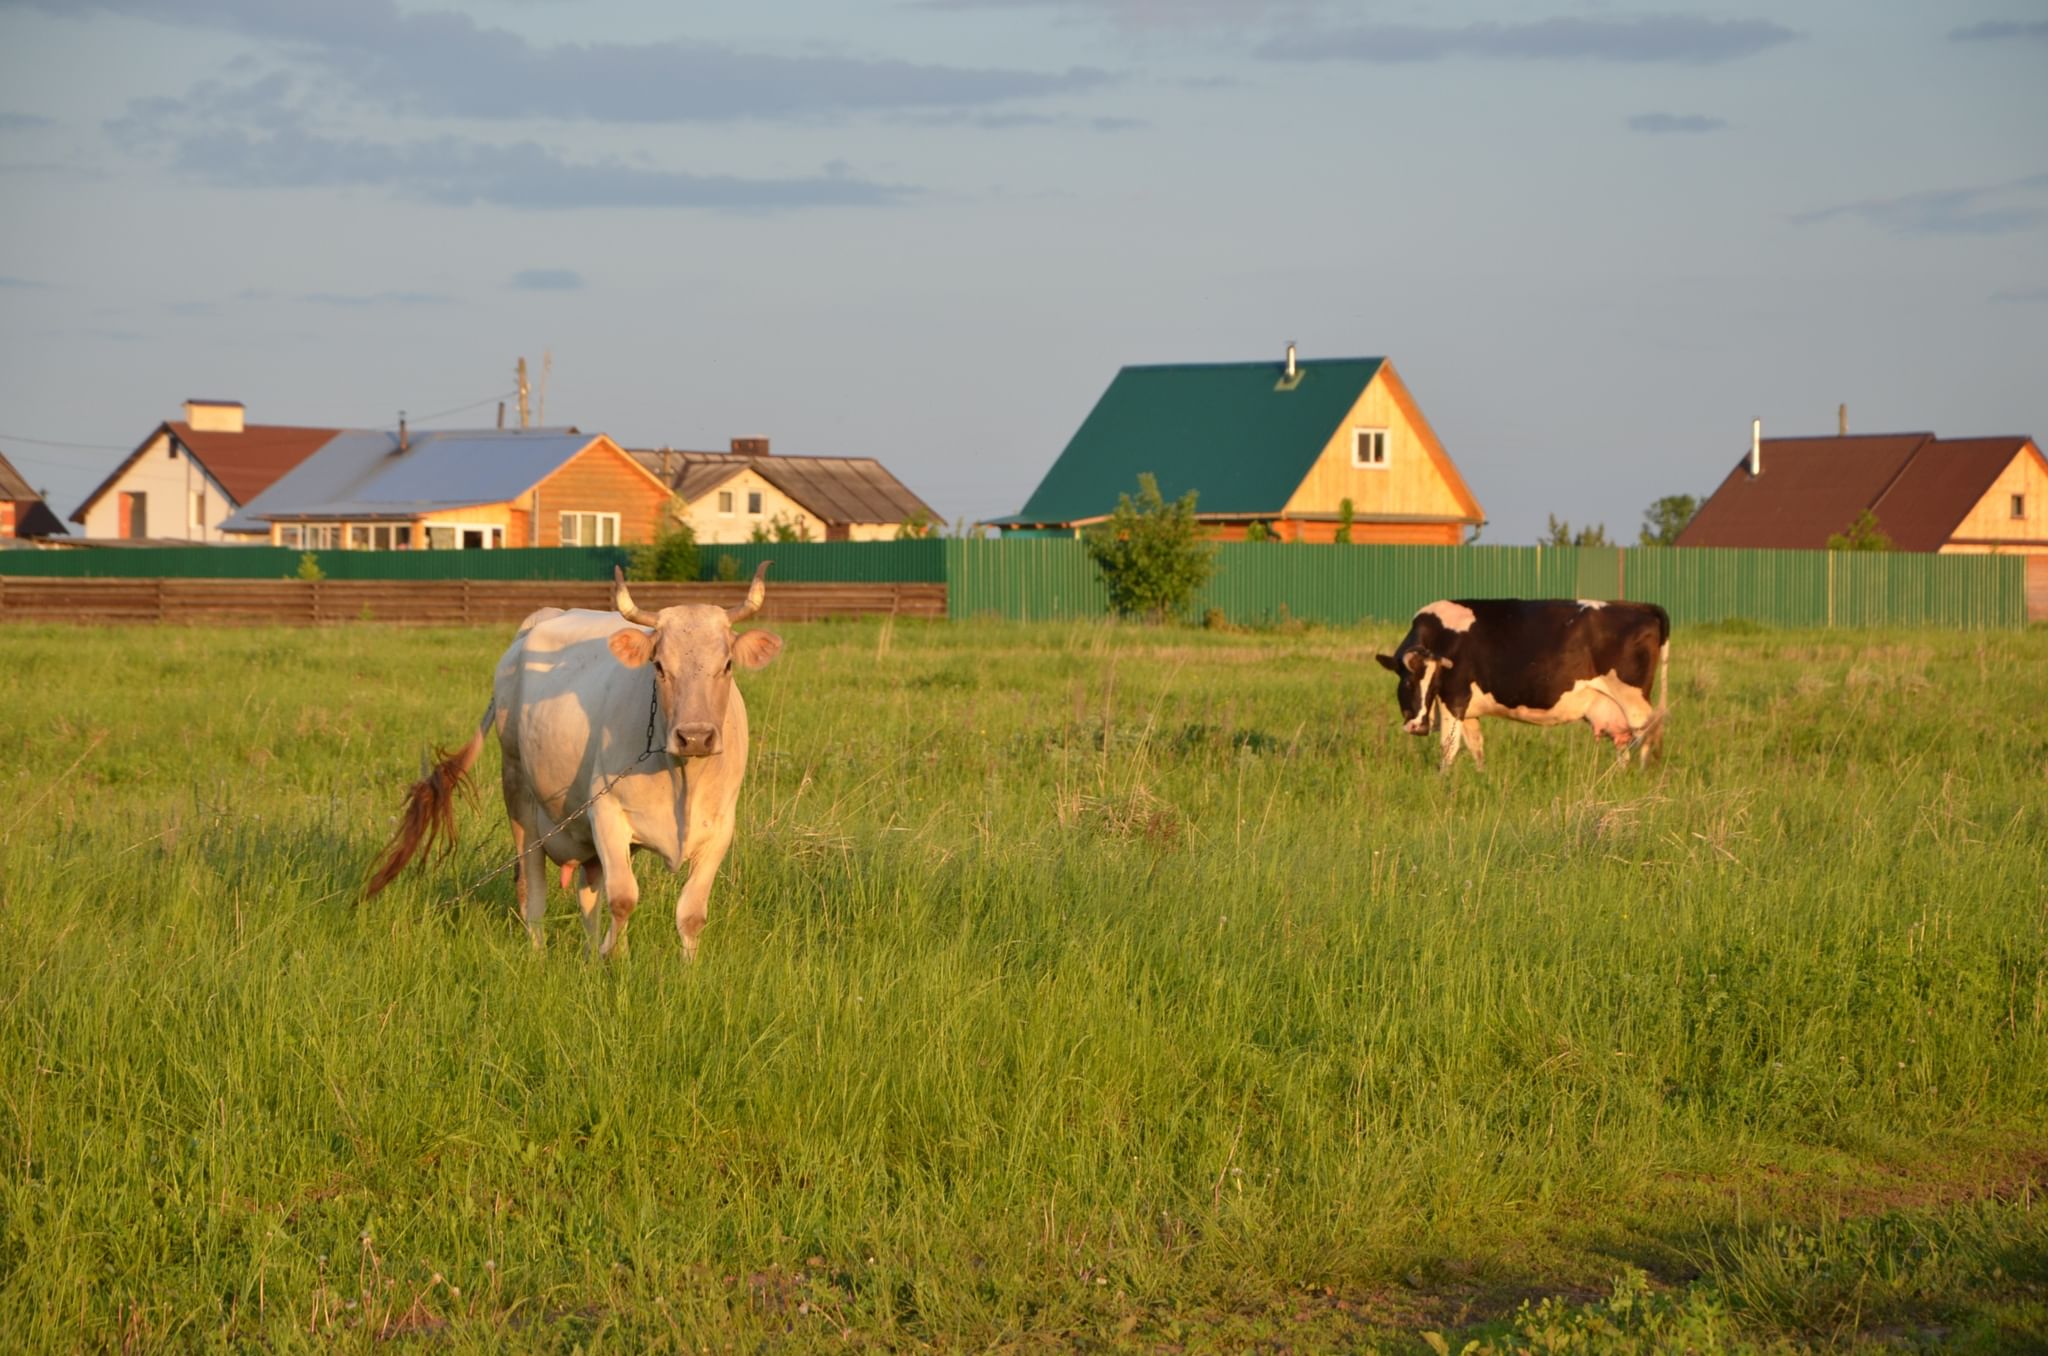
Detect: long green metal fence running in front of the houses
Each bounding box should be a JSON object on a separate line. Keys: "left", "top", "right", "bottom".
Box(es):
{"left": 0, "top": 537, "right": 2025, "bottom": 627}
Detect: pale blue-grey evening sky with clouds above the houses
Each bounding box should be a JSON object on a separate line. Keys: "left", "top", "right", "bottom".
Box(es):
{"left": 0, "top": 0, "right": 2048, "bottom": 543}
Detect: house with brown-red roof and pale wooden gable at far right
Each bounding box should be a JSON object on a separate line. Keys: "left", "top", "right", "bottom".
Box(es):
{"left": 1677, "top": 432, "right": 2048, "bottom": 555}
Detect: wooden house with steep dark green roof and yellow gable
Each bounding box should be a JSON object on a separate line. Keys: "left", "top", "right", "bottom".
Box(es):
{"left": 995, "top": 344, "right": 1485, "bottom": 545}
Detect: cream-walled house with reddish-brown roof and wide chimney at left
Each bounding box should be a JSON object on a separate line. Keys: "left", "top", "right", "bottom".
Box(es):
{"left": 72, "top": 399, "right": 338, "bottom": 543}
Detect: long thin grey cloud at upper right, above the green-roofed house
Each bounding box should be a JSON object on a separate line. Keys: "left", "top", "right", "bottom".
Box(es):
{"left": 1257, "top": 14, "right": 1798, "bottom": 66}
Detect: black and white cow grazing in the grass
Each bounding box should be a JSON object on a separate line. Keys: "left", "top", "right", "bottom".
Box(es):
{"left": 1374, "top": 598, "right": 1671, "bottom": 772}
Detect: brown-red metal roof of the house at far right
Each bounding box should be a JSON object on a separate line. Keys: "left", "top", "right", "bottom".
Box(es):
{"left": 1677, "top": 432, "right": 2030, "bottom": 551}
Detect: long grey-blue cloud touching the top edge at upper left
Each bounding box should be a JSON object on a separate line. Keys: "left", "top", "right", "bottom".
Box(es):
{"left": 20, "top": 0, "right": 1112, "bottom": 123}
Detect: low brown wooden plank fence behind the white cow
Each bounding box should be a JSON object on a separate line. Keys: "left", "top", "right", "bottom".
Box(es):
{"left": 0, "top": 576, "right": 946, "bottom": 627}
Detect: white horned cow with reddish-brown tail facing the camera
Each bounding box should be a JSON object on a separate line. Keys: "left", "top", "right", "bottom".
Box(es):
{"left": 365, "top": 561, "right": 782, "bottom": 957}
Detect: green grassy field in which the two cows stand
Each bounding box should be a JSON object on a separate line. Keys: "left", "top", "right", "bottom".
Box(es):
{"left": 0, "top": 623, "right": 2048, "bottom": 1352}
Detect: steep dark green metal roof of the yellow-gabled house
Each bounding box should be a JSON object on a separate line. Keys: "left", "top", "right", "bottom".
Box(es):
{"left": 997, "top": 358, "right": 1384, "bottom": 524}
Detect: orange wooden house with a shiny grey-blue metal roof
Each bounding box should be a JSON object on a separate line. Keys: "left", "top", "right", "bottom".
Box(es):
{"left": 227, "top": 426, "right": 670, "bottom": 551}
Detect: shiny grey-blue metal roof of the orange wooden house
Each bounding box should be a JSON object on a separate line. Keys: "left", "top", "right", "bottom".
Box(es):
{"left": 221, "top": 428, "right": 610, "bottom": 533}
